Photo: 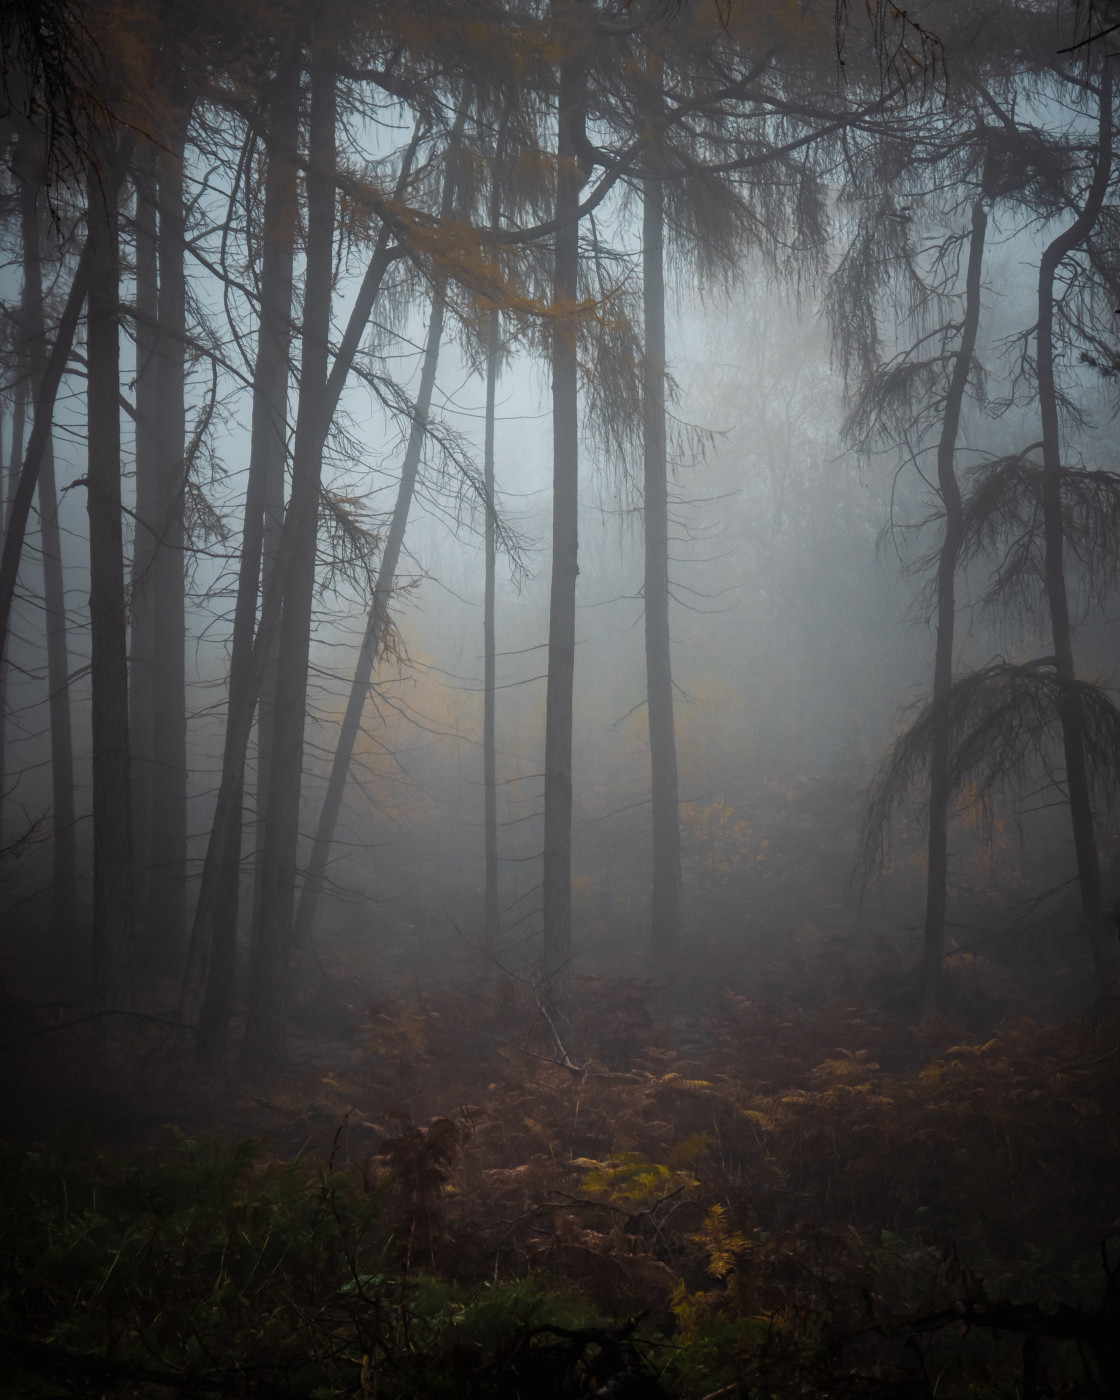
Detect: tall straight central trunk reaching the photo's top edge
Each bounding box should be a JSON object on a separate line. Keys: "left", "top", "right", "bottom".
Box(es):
{"left": 542, "top": 0, "right": 587, "bottom": 1001}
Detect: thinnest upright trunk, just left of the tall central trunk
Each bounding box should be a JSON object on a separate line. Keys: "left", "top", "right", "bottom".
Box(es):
{"left": 482, "top": 305, "right": 501, "bottom": 952}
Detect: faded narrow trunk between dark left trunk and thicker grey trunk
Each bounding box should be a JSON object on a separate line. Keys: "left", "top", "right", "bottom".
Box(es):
{"left": 129, "top": 143, "right": 160, "bottom": 938}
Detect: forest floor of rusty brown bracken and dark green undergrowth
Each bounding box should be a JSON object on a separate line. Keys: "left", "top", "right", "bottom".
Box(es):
{"left": 0, "top": 935, "right": 1120, "bottom": 1400}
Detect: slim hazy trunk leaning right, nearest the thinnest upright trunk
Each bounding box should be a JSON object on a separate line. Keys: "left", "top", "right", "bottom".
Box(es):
{"left": 293, "top": 117, "right": 466, "bottom": 944}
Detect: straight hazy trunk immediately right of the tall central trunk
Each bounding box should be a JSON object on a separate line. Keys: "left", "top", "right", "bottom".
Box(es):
{"left": 641, "top": 178, "right": 680, "bottom": 970}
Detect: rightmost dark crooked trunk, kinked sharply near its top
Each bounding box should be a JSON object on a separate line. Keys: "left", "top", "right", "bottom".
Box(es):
{"left": 1036, "top": 56, "right": 1116, "bottom": 993}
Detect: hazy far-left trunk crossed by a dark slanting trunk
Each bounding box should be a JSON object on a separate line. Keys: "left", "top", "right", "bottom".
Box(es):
{"left": 20, "top": 137, "right": 77, "bottom": 948}
